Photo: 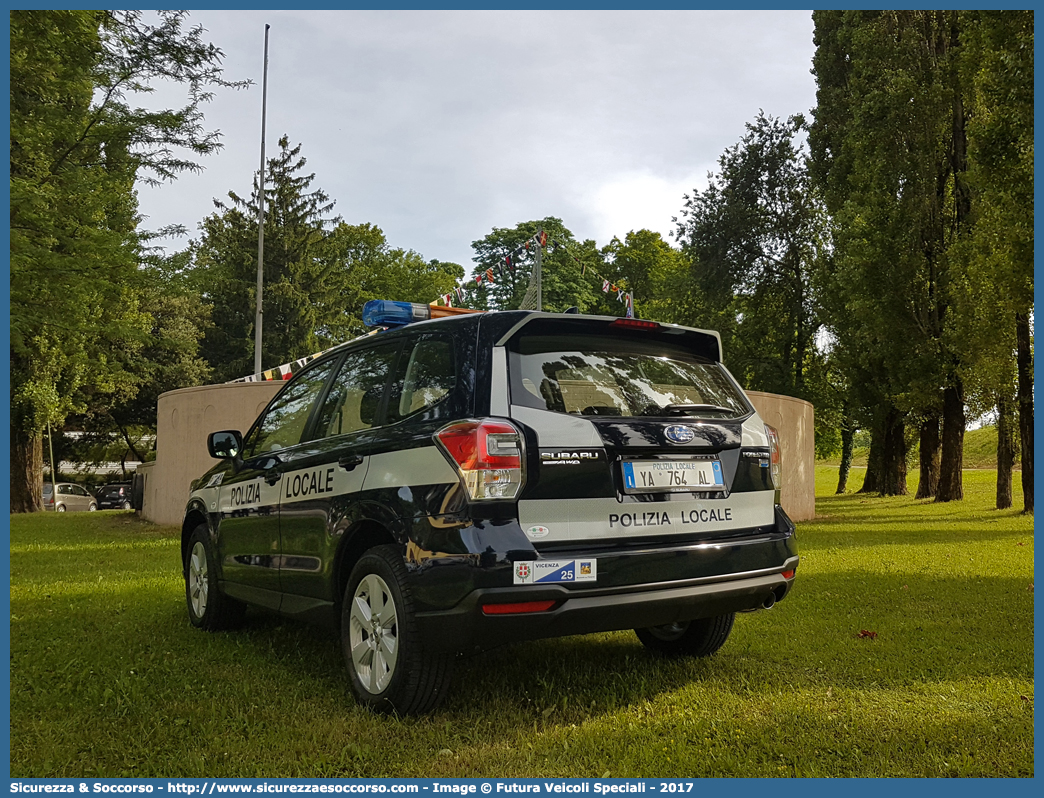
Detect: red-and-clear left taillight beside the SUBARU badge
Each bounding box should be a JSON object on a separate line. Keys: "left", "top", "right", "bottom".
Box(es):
{"left": 435, "top": 421, "right": 525, "bottom": 501}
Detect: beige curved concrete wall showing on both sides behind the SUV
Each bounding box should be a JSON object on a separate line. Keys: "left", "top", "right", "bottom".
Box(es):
{"left": 138, "top": 381, "right": 815, "bottom": 524}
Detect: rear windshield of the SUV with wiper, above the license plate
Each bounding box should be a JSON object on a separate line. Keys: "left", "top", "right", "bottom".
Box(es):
{"left": 509, "top": 335, "right": 752, "bottom": 419}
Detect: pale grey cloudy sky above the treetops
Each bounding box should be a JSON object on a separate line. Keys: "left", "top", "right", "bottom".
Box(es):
{"left": 139, "top": 10, "right": 815, "bottom": 272}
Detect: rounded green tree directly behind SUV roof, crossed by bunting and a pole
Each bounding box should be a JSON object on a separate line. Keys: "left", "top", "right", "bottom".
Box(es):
{"left": 467, "top": 216, "right": 602, "bottom": 313}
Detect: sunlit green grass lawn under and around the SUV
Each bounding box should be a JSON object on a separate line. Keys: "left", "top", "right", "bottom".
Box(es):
{"left": 10, "top": 474, "right": 1034, "bottom": 777}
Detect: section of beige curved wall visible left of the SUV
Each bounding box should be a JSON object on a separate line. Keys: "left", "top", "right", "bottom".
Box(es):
{"left": 138, "top": 380, "right": 283, "bottom": 525}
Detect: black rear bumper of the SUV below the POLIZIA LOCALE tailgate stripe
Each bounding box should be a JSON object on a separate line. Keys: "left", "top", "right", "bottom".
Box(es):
{"left": 411, "top": 507, "right": 799, "bottom": 651}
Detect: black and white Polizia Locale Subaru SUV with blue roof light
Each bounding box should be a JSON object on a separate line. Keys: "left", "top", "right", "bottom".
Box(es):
{"left": 182, "top": 301, "right": 798, "bottom": 713}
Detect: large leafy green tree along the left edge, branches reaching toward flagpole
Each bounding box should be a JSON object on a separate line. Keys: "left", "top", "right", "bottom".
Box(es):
{"left": 10, "top": 10, "right": 240, "bottom": 512}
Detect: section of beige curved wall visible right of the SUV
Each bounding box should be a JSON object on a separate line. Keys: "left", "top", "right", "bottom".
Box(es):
{"left": 746, "top": 391, "right": 815, "bottom": 521}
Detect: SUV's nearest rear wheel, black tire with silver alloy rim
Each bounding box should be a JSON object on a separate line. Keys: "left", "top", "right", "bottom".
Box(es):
{"left": 340, "top": 545, "right": 453, "bottom": 715}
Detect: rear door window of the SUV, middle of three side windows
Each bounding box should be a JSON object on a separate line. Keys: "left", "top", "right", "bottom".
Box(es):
{"left": 315, "top": 343, "right": 399, "bottom": 438}
